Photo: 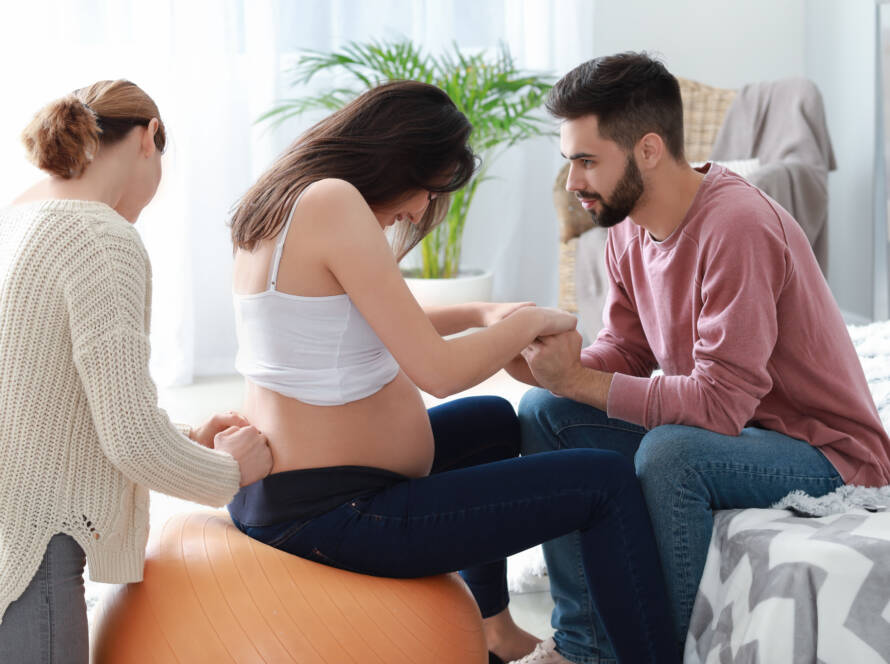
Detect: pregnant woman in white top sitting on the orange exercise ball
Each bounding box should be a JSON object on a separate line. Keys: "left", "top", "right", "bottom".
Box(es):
{"left": 229, "top": 81, "right": 678, "bottom": 664}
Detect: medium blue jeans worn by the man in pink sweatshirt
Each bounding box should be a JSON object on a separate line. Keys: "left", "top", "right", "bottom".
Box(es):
{"left": 519, "top": 389, "right": 843, "bottom": 664}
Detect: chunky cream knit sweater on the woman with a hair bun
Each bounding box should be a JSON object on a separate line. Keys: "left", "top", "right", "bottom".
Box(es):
{"left": 0, "top": 200, "right": 240, "bottom": 621}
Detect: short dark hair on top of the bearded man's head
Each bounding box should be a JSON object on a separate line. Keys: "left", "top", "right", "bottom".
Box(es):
{"left": 547, "top": 52, "right": 683, "bottom": 160}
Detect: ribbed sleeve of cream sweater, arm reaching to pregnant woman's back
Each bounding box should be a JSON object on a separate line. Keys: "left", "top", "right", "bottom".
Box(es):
{"left": 63, "top": 215, "right": 240, "bottom": 506}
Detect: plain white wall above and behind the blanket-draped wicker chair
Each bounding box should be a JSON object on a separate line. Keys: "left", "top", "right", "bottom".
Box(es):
{"left": 592, "top": 0, "right": 880, "bottom": 319}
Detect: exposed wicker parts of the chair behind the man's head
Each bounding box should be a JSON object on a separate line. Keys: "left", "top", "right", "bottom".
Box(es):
{"left": 553, "top": 78, "right": 736, "bottom": 312}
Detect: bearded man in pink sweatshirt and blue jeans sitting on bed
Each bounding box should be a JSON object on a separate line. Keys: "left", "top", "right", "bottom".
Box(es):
{"left": 509, "top": 53, "right": 890, "bottom": 664}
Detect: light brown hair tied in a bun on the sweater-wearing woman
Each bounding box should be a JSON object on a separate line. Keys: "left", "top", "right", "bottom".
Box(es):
{"left": 22, "top": 79, "right": 167, "bottom": 178}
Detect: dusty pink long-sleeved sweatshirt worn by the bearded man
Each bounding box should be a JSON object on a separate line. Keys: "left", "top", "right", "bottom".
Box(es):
{"left": 581, "top": 164, "right": 890, "bottom": 486}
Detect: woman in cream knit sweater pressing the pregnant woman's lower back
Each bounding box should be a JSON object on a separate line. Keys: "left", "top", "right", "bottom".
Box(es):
{"left": 0, "top": 80, "right": 272, "bottom": 664}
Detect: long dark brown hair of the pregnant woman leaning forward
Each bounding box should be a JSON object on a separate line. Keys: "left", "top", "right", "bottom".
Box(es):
{"left": 231, "top": 81, "right": 476, "bottom": 259}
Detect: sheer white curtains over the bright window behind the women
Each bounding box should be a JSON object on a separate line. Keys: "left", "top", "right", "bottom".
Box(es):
{"left": 0, "top": 0, "right": 595, "bottom": 385}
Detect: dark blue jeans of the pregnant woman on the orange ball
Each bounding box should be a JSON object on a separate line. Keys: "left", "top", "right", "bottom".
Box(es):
{"left": 236, "top": 397, "right": 679, "bottom": 664}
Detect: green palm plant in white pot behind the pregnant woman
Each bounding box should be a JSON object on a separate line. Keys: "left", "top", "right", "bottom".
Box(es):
{"left": 259, "top": 41, "right": 551, "bottom": 304}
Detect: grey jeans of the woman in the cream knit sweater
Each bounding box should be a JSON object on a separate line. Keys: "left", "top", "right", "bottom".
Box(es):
{"left": 0, "top": 533, "right": 89, "bottom": 664}
